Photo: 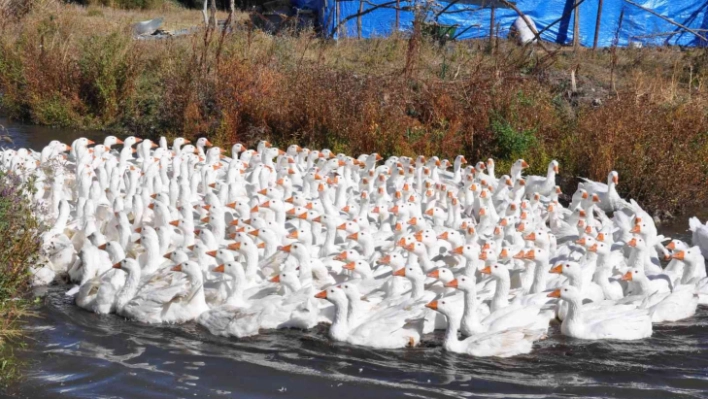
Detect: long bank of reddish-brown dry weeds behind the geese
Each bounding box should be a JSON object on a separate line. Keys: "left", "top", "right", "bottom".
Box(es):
{"left": 0, "top": 3, "right": 708, "bottom": 216}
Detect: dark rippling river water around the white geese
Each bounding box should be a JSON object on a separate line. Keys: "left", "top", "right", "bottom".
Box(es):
{"left": 0, "top": 119, "right": 708, "bottom": 399}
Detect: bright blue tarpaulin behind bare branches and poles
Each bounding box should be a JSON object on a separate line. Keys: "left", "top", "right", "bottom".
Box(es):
{"left": 294, "top": 0, "right": 708, "bottom": 47}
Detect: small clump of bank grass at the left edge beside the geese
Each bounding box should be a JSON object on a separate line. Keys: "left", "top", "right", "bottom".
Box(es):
{"left": 0, "top": 166, "right": 41, "bottom": 387}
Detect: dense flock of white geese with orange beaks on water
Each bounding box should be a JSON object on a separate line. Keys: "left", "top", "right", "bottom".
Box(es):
{"left": 0, "top": 136, "right": 708, "bottom": 357}
